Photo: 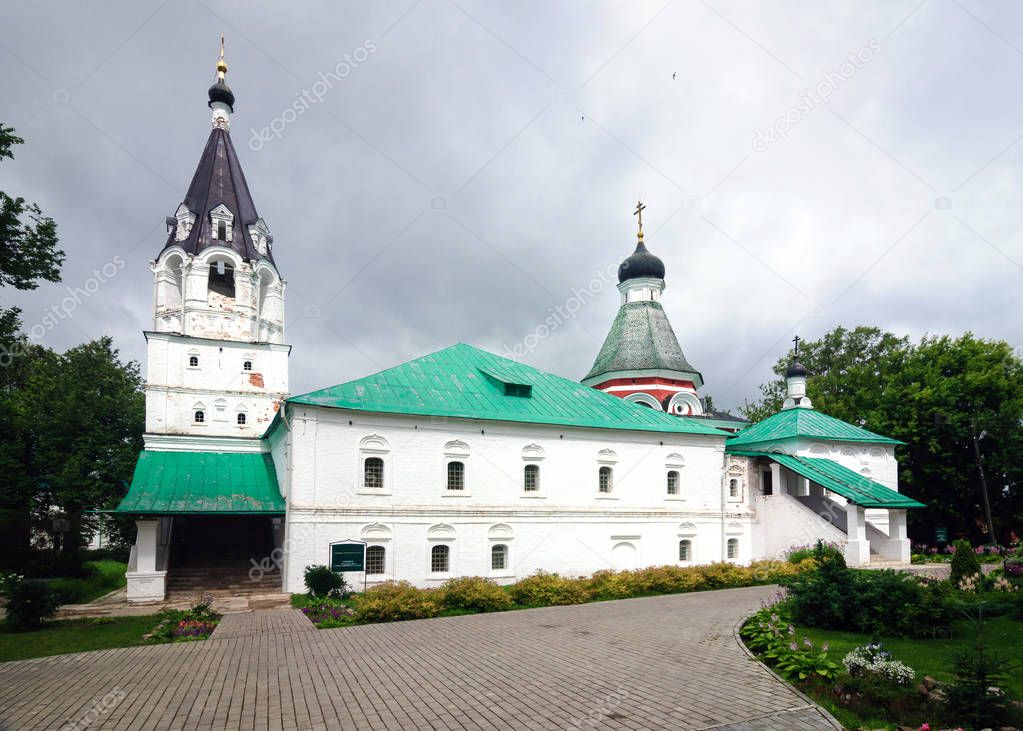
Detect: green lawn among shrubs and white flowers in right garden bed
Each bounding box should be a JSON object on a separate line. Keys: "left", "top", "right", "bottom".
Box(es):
{"left": 797, "top": 616, "right": 1023, "bottom": 698}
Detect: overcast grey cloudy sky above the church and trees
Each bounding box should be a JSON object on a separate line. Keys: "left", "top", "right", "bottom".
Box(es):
{"left": 0, "top": 0, "right": 1023, "bottom": 407}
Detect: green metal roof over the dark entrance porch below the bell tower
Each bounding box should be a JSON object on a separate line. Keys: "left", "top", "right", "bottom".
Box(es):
{"left": 114, "top": 451, "right": 284, "bottom": 515}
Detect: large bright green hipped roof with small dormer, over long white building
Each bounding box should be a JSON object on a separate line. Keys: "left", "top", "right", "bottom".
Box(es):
{"left": 287, "top": 342, "right": 725, "bottom": 438}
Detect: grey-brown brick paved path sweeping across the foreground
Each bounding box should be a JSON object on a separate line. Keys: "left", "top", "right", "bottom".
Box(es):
{"left": 0, "top": 587, "right": 835, "bottom": 731}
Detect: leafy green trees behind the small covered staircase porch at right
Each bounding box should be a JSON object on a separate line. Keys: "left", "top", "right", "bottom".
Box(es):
{"left": 743, "top": 326, "right": 1023, "bottom": 542}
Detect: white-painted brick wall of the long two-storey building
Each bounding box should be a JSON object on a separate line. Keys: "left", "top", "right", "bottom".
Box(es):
{"left": 273, "top": 406, "right": 752, "bottom": 591}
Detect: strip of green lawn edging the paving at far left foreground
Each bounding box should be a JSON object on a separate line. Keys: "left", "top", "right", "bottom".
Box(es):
{"left": 0, "top": 614, "right": 160, "bottom": 661}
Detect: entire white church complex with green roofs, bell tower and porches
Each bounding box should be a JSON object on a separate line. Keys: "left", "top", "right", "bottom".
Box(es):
{"left": 116, "top": 53, "right": 920, "bottom": 601}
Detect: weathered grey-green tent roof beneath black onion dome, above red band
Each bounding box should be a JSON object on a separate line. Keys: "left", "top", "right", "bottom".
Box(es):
{"left": 583, "top": 302, "right": 703, "bottom": 387}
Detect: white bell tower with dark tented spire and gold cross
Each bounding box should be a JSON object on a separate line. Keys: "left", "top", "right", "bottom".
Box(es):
{"left": 145, "top": 39, "right": 291, "bottom": 449}
